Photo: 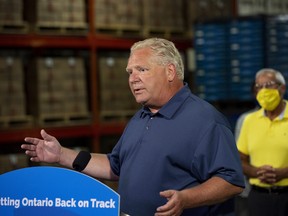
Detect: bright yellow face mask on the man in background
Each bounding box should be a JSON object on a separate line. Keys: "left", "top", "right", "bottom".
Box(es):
{"left": 256, "top": 88, "right": 281, "bottom": 111}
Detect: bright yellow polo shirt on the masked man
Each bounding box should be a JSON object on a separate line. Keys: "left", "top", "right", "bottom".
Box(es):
{"left": 237, "top": 101, "right": 288, "bottom": 187}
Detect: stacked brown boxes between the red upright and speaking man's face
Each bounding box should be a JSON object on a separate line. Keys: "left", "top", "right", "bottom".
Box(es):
{"left": 99, "top": 52, "right": 139, "bottom": 119}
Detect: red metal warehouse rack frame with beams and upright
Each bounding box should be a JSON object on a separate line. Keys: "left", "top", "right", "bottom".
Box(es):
{"left": 0, "top": 0, "right": 192, "bottom": 152}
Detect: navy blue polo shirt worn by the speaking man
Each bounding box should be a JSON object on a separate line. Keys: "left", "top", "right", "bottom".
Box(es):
{"left": 108, "top": 85, "right": 244, "bottom": 216}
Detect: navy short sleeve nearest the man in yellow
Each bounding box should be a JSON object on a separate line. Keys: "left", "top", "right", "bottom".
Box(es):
{"left": 193, "top": 123, "right": 244, "bottom": 187}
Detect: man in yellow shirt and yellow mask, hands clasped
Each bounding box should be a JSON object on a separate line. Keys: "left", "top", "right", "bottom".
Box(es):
{"left": 237, "top": 68, "right": 288, "bottom": 216}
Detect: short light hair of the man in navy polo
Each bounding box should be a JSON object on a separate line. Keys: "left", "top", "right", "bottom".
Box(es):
{"left": 130, "top": 38, "right": 184, "bottom": 80}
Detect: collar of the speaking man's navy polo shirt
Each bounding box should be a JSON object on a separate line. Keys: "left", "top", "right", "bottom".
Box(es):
{"left": 140, "top": 83, "right": 191, "bottom": 119}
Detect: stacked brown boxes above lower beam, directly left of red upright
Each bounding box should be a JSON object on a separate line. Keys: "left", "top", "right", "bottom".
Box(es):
{"left": 34, "top": 57, "right": 89, "bottom": 124}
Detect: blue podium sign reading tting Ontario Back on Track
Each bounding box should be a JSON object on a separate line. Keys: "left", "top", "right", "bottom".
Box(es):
{"left": 0, "top": 166, "right": 120, "bottom": 216}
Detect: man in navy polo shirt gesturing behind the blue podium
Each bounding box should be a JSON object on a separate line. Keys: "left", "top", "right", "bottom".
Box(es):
{"left": 22, "top": 38, "right": 244, "bottom": 216}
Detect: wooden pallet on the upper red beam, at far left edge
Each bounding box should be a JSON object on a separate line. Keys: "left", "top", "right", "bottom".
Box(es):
{"left": 0, "top": 22, "right": 29, "bottom": 34}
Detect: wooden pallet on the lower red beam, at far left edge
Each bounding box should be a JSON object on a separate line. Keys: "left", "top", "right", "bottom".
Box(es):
{"left": 0, "top": 116, "right": 33, "bottom": 129}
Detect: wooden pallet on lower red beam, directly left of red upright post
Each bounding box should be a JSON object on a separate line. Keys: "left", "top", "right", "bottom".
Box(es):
{"left": 38, "top": 113, "right": 92, "bottom": 126}
